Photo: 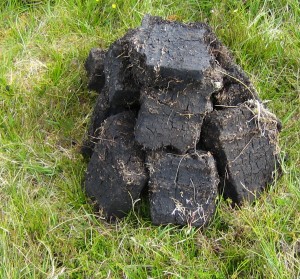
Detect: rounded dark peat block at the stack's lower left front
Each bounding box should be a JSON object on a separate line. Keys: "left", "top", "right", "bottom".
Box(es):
{"left": 85, "top": 112, "right": 148, "bottom": 219}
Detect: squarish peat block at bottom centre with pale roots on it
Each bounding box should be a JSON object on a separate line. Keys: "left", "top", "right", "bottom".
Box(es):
{"left": 147, "top": 151, "right": 219, "bottom": 227}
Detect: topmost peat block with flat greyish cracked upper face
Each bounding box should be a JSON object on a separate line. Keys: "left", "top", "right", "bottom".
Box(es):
{"left": 129, "top": 15, "right": 220, "bottom": 87}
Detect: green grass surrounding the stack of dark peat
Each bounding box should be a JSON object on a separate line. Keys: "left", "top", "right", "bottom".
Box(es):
{"left": 0, "top": 0, "right": 300, "bottom": 278}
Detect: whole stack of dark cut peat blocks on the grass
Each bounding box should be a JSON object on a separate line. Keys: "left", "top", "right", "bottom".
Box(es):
{"left": 82, "top": 15, "right": 280, "bottom": 227}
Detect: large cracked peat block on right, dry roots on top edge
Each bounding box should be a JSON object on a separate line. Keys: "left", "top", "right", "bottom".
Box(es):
{"left": 201, "top": 102, "right": 278, "bottom": 204}
